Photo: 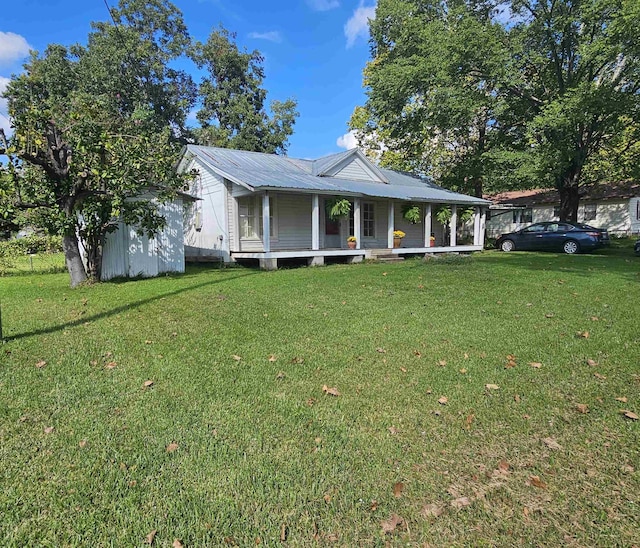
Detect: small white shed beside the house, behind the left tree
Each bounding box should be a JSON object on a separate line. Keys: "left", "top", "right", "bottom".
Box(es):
{"left": 100, "top": 192, "right": 194, "bottom": 280}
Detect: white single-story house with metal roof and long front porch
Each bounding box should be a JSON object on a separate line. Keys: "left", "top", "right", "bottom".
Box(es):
{"left": 180, "top": 145, "right": 489, "bottom": 269}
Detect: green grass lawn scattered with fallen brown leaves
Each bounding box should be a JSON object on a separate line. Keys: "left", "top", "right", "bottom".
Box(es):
{"left": 0, "top": 243, "right": 640, "bottom": 546}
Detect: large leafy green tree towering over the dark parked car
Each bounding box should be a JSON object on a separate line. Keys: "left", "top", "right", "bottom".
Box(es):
{"left": 351, "top": 0, "right": 640, "bottom": 220}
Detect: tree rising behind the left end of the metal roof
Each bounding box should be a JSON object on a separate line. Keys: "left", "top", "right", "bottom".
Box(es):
{"left": 192, "top": 28, "right": 298, "bottom": 153}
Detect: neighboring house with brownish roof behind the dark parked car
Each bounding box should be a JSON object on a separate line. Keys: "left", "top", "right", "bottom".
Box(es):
{"left": 486, "top": 181, "right": 640, "bottom": 238}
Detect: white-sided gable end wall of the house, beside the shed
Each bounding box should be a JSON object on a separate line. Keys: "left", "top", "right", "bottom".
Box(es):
{"left": 184, "top": 162, "right": 235, "bottom": 260}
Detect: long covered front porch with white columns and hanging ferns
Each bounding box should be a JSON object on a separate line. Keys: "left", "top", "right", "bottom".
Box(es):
{"left": 231, "top": 190, "right": 486, "bottom": 270}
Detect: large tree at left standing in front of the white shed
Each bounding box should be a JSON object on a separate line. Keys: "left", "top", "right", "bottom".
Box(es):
{"left": 0, "top": 0, "right": 195, "bottom": 286}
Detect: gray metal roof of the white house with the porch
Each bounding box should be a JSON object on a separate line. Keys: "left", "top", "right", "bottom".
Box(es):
{"left": 187, "top": 145, "right": 490, "bottom": 205}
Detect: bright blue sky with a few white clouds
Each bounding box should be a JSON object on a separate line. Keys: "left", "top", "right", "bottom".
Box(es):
{"left": 0, "top": 0, "right": 375, "bottom": 158}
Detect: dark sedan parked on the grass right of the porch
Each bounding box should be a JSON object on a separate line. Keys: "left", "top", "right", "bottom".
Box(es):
{"left": 496, "top": 221, "right": 610, "bottom": 255}
